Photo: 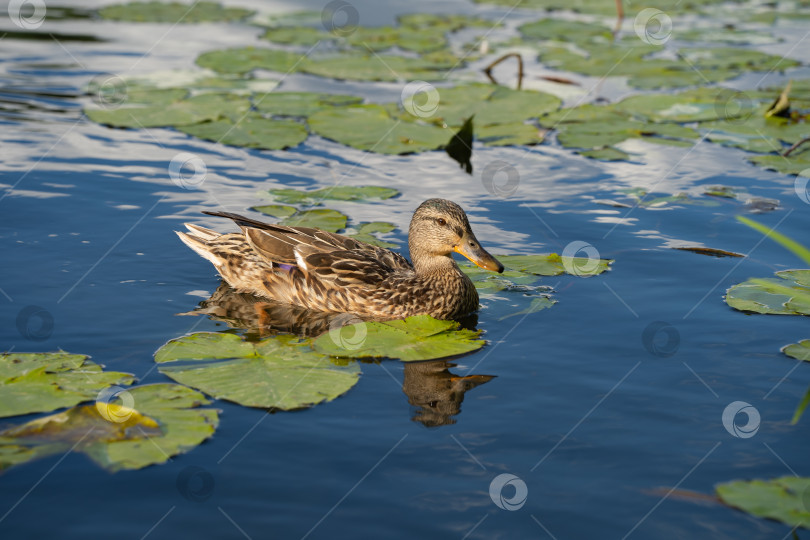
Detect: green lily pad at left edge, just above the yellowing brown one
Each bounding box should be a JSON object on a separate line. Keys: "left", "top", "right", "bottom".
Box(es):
{"left": 0, "top": 352, "right": 135, "bottom": 417}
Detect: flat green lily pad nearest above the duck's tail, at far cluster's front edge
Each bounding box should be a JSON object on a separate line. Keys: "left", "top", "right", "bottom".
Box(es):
{"left": 178, "top": 113, "right": 309, "bottom": 150}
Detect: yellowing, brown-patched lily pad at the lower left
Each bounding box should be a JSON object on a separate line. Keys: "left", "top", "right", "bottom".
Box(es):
{"left": 0, "top": 384, "right": 219, "bottom": 472}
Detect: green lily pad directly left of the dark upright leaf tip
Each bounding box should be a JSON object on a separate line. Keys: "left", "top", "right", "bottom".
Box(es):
{"left": 309, "top": 105, "right": 452, "bottom": 154}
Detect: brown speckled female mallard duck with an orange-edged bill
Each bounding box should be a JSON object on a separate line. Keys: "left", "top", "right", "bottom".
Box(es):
{"left": 177, "top": 199, "right": 503, "bottom": 319}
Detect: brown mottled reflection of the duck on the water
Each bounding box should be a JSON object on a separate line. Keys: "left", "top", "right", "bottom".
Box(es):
{"left": 182, "top": 281, "right": 494, "bottom": 427}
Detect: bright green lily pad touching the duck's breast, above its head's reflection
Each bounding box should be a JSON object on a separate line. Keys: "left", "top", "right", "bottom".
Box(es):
{"left": 313, "top": 315, "right": 485, "bottom": 362}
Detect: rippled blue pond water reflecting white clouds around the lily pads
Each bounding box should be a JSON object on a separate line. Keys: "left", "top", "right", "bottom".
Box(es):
{"left": 0, "top": 1, "right": 810, "bottom": 539}
